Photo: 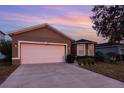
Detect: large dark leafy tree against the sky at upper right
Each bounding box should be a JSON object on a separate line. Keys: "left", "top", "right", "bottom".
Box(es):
{"left": 91, "top": 5, "right": 124, "bottom": 43}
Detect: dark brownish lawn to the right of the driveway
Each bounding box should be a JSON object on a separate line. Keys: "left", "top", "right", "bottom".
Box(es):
{"left": 81, "top": 62, "right": 124, "bottom": 82}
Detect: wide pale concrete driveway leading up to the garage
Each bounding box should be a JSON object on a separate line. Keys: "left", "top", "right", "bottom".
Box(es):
{"left": 0, "top": 63, "right": 124, "bottom": 88}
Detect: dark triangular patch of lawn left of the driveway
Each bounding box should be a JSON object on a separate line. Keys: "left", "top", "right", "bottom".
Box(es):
{"left": 0, "top": 62, "right": 18, "bottom": 84}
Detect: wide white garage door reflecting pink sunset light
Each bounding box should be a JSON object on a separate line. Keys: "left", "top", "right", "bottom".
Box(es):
{"left": 21, "top": 44, "right": 65, "bottom": 64}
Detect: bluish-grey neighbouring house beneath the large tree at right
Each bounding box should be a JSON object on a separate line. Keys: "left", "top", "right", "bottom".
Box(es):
{"left": 95, "top": 43, "right": 124, "bottom": 60}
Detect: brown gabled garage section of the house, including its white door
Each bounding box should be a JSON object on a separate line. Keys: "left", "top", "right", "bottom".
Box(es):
{"left": 9, "top": 24, "right": 72, "bottom": 64}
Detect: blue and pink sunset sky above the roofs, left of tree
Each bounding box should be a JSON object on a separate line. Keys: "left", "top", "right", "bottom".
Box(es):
{"left": 0, "top": 5, "right": 106, "bottom": 43}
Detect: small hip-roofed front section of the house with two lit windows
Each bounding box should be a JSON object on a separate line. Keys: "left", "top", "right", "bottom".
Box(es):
{"left": 72, "top": 39, "right": 96, "bottom": 56}
